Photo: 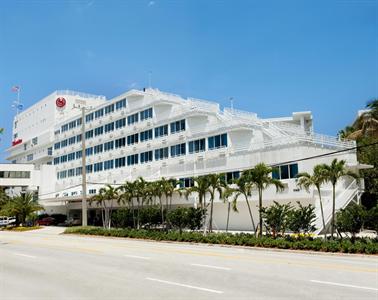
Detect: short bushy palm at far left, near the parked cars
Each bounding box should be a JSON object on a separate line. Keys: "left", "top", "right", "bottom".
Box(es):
{"left": 1, "top": 193, "right": 43, "bottom": 224}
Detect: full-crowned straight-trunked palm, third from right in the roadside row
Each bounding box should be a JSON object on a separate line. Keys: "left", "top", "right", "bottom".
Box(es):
{"left": 243, "top": 163, "right": 284, "bottom": 236}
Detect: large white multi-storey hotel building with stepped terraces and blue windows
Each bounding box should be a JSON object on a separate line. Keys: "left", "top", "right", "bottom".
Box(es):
{"left": 4, "top": 89, "right": 363, "bottom": 230}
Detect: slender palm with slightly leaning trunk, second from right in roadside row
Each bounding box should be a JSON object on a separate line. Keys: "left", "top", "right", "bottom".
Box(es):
{"left": 296, "top": 165, "right": 327, "bottom": 238}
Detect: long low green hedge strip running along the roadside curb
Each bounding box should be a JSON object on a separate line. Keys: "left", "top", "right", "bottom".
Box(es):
{"left": 64, "top": 227, "right": 378, "bottom": 254}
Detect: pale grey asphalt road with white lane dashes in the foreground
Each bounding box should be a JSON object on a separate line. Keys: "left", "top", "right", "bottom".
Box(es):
{"left": 0, "top": 228, "right": 378, "bottom": 300}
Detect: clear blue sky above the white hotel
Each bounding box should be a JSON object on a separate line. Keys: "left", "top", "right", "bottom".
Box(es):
{"left": 0, "top": 0, "right": 378, "bottom": 162}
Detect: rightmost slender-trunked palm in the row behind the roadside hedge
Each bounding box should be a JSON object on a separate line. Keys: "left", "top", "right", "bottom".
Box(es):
{"left": 321, "top": 158, "right": 359, "bottom": 239}
